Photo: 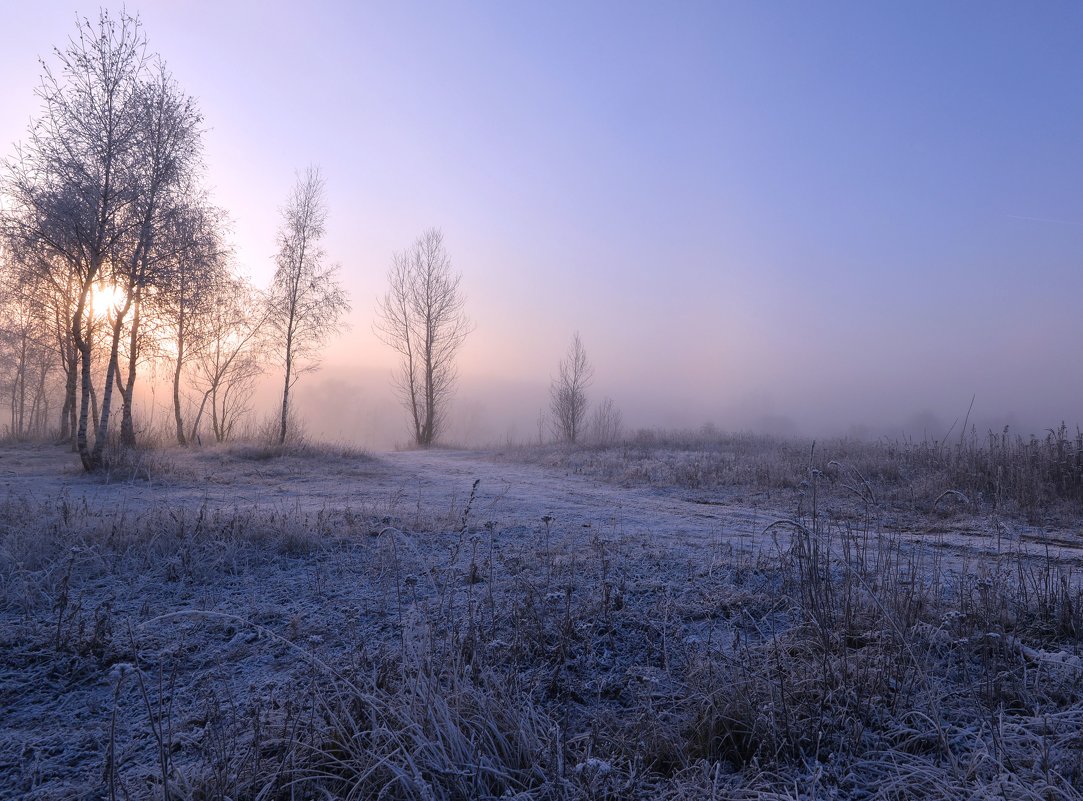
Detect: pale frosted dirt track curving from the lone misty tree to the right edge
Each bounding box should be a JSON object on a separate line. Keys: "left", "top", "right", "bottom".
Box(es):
{"left": 382, "top": 450, "right": 1083, "bottom": 570}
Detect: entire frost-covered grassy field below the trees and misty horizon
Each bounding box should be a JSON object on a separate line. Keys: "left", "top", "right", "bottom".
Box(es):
{"left": 0, "top": 439, "right": 1083, "bottom": 800}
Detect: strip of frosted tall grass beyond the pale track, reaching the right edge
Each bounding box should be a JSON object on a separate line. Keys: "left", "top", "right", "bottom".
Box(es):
{"left": 504, "top": 425, "right": 1083, "bottom": 522}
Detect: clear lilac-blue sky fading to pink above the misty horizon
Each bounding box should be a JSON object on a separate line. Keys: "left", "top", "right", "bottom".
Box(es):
{"left": 0, "top": 0, "right": 1083, "bottom": 445}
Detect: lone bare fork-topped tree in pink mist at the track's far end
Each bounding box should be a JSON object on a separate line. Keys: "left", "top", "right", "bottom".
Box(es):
{"left": 375, "top": 228, "right": 470, "bottom": 447}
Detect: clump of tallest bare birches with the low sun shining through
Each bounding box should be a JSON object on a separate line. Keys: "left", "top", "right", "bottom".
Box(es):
{"left": 2, "top": 11, "right": 213, "bottom": 470}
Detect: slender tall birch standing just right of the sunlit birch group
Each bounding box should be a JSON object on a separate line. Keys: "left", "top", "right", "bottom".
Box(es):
{"left": 268, "top": 167, "right": 350, "bottom": 444}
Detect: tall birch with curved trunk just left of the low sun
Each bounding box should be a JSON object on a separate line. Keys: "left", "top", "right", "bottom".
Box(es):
{"left": 3, "top": 11, "right": 146, "bottom": 470}
